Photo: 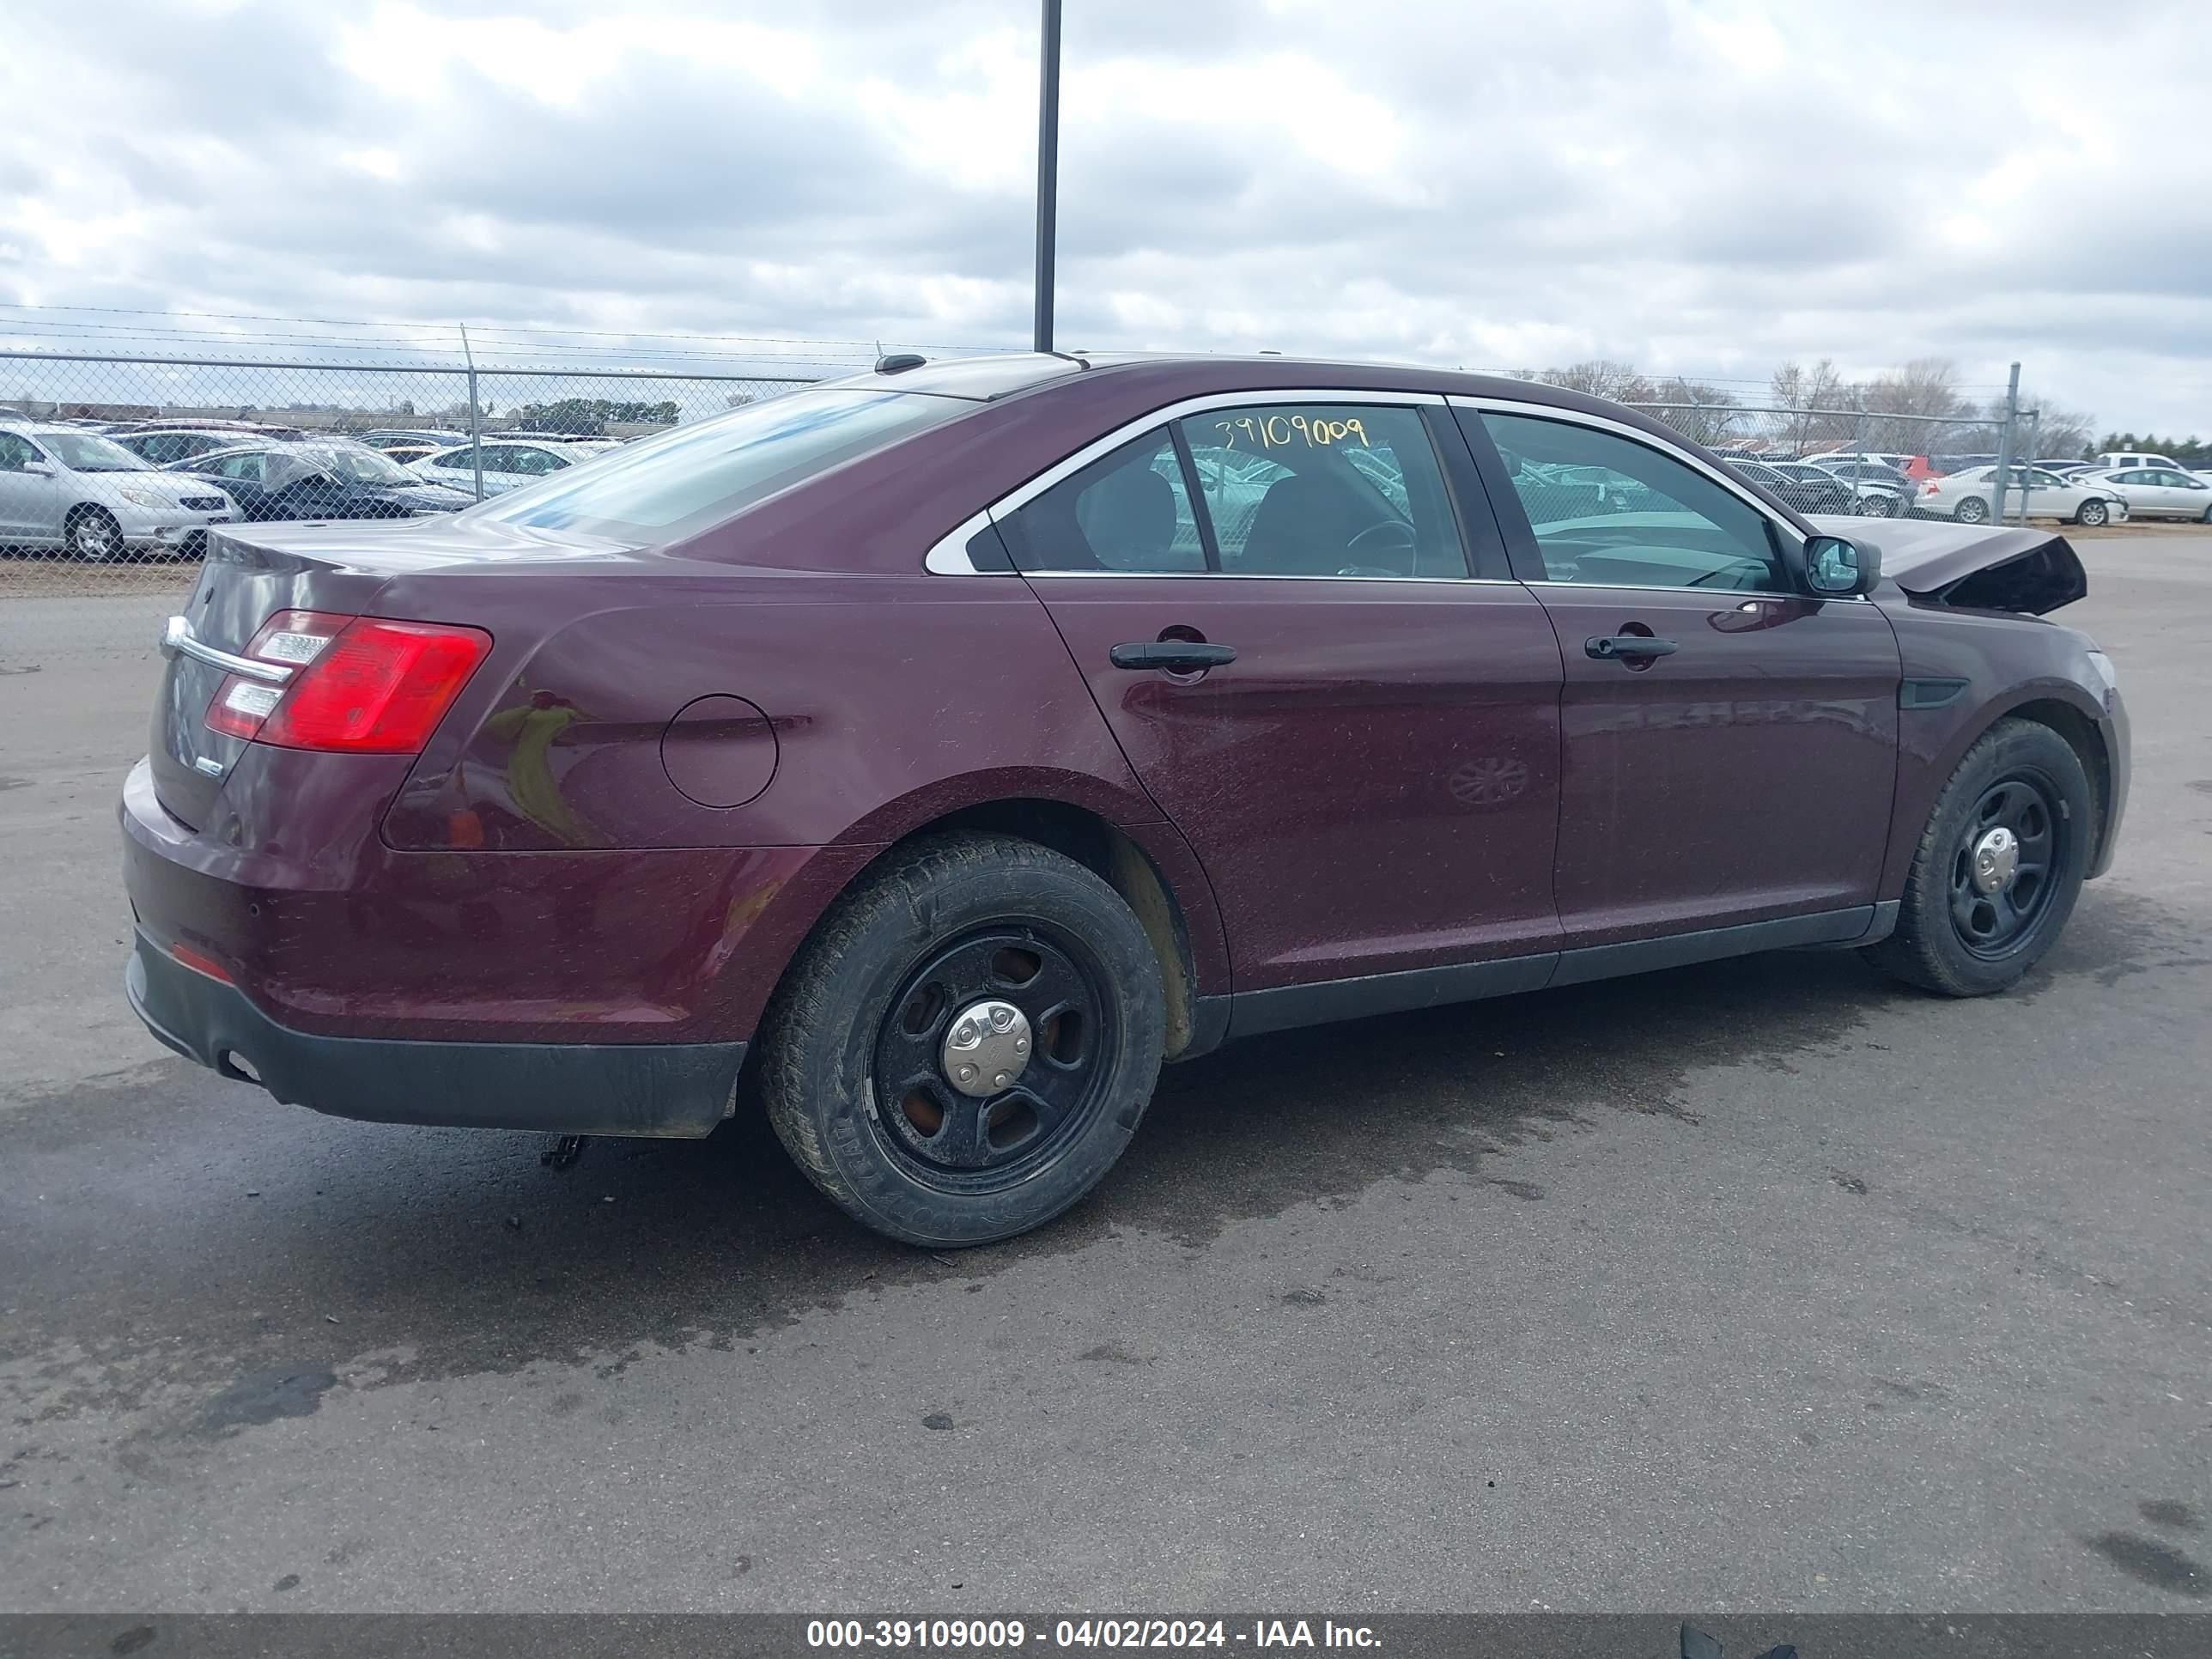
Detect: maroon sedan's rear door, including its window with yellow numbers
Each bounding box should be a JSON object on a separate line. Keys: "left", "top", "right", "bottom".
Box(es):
{"left": 995, "top": 398, "right": 1559, "bottom": 1000}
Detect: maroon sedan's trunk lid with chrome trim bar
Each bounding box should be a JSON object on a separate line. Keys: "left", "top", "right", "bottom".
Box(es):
{"left": 146, "top": 515, "right": 641, "bottom": 830}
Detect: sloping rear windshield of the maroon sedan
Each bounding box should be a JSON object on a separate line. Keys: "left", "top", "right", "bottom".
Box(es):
{"left": 469, "top": 387, "right": 975, "bottom": 533}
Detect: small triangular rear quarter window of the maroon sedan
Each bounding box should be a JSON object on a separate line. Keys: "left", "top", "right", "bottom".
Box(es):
{"left": 998, "top": 427, "right": 1206, "bottom": 575}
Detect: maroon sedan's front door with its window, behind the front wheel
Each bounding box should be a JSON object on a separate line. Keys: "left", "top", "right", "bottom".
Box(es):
{"left": 1462, "top": 410, "right": 1900, "bottom": 947}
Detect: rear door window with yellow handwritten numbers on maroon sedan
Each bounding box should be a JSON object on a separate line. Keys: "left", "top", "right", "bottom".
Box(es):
{"left": 1176, "top": 403, "right": 1467, "bottom": 577}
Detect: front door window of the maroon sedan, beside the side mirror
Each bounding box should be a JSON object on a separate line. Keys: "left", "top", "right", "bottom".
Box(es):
{"left": 1482, "top": 411, "right": 1790, "bottom": 592}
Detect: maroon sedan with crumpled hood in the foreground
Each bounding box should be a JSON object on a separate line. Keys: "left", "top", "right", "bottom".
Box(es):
{"left": 122, "top": 356, "right": 2128, "bottom": 1245}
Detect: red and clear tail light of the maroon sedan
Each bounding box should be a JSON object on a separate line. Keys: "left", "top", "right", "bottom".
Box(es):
{"left": 208, "top": 611, "right": 491, "bottom": 754}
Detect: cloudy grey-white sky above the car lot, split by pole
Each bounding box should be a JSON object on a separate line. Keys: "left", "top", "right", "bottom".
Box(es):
{"left": 0, "top": 0, "right": 2212, "bottom": 431}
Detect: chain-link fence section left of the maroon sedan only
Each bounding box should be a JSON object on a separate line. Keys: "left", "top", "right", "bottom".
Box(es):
{"left": 0, "top": 349, "right": 817, "bottom": 604}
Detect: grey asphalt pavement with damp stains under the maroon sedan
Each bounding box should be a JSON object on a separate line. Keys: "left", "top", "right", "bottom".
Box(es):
{"left": 0, "top": 535, "right": 2212, "bottom": 1614}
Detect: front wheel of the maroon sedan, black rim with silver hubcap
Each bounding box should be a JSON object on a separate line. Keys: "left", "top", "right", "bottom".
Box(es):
{"left": 1863, "top": 719, "right": 2097, "bottom": 998}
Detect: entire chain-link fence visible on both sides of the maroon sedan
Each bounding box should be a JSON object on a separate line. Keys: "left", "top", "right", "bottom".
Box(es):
{"left": 0, "top": 349, "right": 2070, "bottom": 604}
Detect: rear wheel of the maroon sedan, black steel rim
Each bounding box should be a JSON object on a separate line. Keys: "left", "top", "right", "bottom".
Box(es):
{"left": 759, "top": 834, "right": 1166, "bottom": 1249}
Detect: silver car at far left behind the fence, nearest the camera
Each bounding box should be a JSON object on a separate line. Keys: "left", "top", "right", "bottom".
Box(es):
{"left": 0, "top": 422, "right": 237, "bottom": 564}
